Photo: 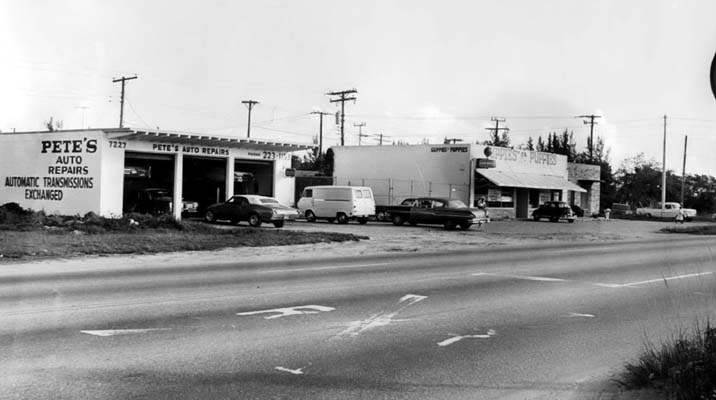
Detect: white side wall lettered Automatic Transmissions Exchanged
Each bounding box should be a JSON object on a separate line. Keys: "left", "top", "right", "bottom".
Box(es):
{"left": 0, "top": 132, "right": 102, "bottom": 214}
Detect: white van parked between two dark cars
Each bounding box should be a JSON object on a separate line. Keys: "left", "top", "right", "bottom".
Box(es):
{"left": 296, "top": 186, "right": 375, "bottom": 224}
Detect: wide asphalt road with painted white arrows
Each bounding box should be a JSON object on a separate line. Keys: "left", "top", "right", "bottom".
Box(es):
{"left": 0, "top": 237, "right": 716, "bottom": 399}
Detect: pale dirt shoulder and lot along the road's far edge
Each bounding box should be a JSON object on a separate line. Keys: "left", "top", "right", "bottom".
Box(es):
{"left": 0, "top": 218, "right": 712, "bottom": 274}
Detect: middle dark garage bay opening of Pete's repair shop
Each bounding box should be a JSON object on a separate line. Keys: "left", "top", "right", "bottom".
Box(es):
{"left": 182, "top": 156, "right": 227, "bottom": 215}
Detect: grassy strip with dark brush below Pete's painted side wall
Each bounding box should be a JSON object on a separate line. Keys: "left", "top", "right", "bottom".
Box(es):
{"left": 0, "top": 203, "right": 368, "bottom": 259}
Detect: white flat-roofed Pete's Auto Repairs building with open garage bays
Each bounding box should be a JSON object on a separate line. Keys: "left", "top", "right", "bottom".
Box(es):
{"left": 0, "top": 128, "right": 311, "bottom": 219}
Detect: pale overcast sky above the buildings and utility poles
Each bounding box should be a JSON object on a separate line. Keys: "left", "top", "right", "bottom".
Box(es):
{"left": 0, "top": 0, "right": 716, "bottom": 176}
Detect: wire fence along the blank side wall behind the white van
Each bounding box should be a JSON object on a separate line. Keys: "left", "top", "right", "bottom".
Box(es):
{"left": 333, "top": 177, "right": 470, "bottom": 205}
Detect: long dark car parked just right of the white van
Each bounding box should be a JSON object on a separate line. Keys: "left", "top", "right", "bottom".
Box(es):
{"left": 376, "top": 197, "right": 488, "bottom": 230}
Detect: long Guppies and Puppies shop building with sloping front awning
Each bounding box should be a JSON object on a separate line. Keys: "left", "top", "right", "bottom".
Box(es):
{"left": 332, "top": 144, "right": 599, "bottom": 218}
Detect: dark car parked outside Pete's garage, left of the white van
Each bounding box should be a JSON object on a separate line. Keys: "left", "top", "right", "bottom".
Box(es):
{"left": 204, "top": 194, "right": 299, "bottom": 228}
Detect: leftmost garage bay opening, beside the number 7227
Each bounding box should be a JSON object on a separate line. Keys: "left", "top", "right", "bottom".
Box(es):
{"left": 122, "top": 152, "right": 174, "bottom": 214}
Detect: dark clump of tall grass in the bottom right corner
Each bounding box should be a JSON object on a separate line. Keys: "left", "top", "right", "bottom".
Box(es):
{"left": 616, "top": 322, "right": 716, "bottom": 400}
